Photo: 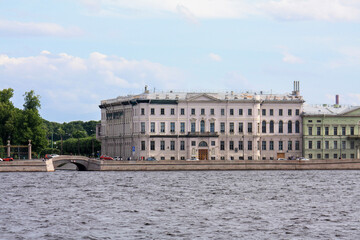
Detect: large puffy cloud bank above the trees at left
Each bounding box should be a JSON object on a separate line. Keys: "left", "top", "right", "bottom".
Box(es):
{"left": 0, "top": 50, "right": 184, "bottom": 121}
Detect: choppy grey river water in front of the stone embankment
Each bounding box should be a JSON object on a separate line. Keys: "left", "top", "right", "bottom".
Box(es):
{"left": 0, "top": 171, "right": 360, "bottom": 239}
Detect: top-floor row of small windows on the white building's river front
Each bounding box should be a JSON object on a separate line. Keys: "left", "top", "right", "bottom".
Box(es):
{"left": 141, "top": 108, "right": 300, "bottom": 116}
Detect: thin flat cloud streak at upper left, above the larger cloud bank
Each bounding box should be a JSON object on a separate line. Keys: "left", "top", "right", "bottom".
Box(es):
{"left": 0, "top": 20, "right": 83, "bottom": 37}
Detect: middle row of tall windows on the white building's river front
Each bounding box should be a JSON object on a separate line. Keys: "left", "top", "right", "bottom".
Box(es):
{"left": 140, "top": 120, "right": 300, "bottom": 133}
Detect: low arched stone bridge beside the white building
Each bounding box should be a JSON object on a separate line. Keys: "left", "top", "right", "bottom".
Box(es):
{"left": 51, "top": 155, "right": 101, "bottom": 171}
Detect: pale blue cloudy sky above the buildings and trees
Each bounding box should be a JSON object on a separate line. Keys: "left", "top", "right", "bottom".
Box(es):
{"left": 0, "top": 0, "right": 360, "bottom": 122}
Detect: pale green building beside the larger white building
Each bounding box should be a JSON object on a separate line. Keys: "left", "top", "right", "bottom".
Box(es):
{"left": 303, "top": 105, "right": 360, "bottom": 159}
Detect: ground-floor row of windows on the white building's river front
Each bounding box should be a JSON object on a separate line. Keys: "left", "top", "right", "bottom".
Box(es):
{"left": 141, "top": 140, "right": 300, "bottom": 151}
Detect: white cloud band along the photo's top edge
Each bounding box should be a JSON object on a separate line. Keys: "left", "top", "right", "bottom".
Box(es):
{"left": 77, "top": 0, "right": 360, "bottom": 22}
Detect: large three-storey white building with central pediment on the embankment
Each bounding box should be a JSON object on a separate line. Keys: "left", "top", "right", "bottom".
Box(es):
{"left": 97, "top": 82, "right": 304, "bottom": 160}
